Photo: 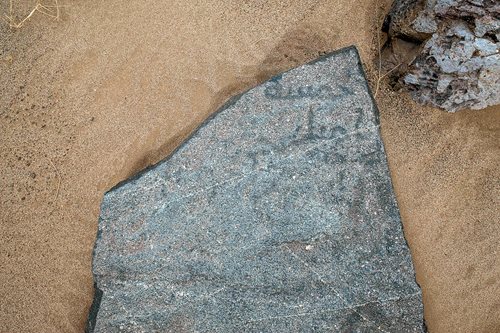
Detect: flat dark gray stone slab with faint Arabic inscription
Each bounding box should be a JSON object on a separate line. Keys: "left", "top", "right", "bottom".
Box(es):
{"left": 88, "top": 47, "right": 424, "bottom": 332}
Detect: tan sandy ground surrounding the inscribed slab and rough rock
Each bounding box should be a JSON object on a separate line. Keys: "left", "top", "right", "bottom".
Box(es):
{"left": 0, "top": 0, "right": 500, "bottom": 333}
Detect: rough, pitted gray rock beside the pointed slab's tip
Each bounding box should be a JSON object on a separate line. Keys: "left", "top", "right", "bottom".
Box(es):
{"left": 387, "top": 0, "right": 500, "bottom": 112}
